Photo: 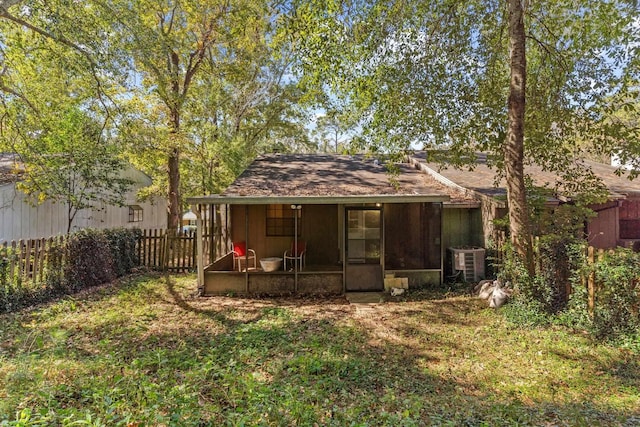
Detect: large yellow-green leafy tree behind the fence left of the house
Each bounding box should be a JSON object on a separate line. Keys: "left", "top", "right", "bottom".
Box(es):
{"left": 0, "top": 0, "right": 309, "bottom": 226}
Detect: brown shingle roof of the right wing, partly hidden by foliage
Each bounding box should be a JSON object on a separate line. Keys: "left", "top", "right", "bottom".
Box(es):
{"left": 413, "top": 152, "right": 640, "bottom": 201}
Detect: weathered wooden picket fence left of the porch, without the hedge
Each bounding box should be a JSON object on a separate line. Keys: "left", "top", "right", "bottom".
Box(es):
{"left": 0, "top": 229, "right": 220, "bottom": 284}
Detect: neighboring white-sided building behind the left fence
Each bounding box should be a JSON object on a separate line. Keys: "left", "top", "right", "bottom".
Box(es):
{"left": 0, "top": 154, "right": 167, "bottom": 243}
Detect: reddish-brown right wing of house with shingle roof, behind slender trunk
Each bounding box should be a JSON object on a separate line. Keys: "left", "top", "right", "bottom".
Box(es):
{"left": 409, "top": 152, "right": 640, "bottom": 249}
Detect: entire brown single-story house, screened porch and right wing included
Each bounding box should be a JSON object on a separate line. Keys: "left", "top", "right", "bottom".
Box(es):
{"left": 188, "top": 152, "right": 640, "bottom": 295}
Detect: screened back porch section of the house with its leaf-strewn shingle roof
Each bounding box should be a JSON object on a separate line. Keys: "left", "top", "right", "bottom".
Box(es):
{"left": 188, "top": 154, "right": 479, "bottom": 295}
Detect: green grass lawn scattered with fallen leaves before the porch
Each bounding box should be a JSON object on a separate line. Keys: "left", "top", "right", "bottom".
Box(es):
{"left": 0, "top": 276, "right": 640, "bottom": 426}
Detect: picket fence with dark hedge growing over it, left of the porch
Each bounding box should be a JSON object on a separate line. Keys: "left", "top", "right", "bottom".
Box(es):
{"left": 0, "top": 228, "right": 218, "bottom": 312}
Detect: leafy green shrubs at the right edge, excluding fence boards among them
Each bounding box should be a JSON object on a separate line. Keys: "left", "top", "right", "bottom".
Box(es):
{"left": 500, "top": 242, "right": 640, "bottom": 351}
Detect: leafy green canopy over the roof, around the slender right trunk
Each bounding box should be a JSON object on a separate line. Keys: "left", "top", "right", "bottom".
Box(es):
{"left": 288, "top": 0, "right": 640, "bottom": 179}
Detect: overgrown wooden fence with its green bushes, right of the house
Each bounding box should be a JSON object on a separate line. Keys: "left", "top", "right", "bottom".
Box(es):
{"left": 496, "top": 236, "right": 640, "bottom": 340}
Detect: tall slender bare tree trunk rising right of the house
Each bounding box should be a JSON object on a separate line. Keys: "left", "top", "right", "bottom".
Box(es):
{"left": 504, "top": 0, "right": 534, "bottom": 274}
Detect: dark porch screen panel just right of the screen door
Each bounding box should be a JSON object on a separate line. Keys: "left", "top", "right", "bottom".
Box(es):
{"left": 384, "top": 203, "right": 442, "bottom": 270}
